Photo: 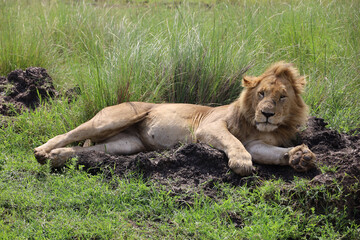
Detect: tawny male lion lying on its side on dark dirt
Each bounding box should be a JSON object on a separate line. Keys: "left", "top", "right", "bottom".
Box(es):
{"left": 35, "top": 62, "right": 315, "bottom": 176}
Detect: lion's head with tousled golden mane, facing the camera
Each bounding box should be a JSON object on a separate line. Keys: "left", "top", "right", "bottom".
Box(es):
{"left": 239, "top": 62, "right": 308, "bottom": 137}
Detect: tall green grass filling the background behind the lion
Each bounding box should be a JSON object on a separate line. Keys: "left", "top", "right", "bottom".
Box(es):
{"left": 0, "top": 0, "right": 360, "bottom": 130}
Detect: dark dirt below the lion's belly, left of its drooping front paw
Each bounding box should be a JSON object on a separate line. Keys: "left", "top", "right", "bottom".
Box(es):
{"left": 78, "top": 143, "right": 232, "bottom": 191}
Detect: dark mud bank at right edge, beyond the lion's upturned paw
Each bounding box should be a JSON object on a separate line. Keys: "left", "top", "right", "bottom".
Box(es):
{"left": 301, "top": 117, "right": 360, "bottom": 220}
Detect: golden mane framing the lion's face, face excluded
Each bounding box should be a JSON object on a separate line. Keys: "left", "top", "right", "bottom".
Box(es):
{"left": 230, "top": 62, "right": 308, "bottom": 146}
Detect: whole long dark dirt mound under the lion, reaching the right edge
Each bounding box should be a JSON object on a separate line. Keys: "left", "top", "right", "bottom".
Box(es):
{"left": 74, "top": 117, "right": 360, "bottom": 218}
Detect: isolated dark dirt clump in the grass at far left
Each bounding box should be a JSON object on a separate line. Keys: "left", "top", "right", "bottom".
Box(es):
{"left": 0, "top": 67, "right": 59, "bottom": 116}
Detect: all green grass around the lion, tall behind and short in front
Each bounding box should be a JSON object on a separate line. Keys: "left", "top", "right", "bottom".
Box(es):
{"left": 0, "top": 0, "right": 360, "bottom": 239}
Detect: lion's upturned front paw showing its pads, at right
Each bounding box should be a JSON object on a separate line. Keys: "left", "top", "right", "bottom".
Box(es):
{"left": 288, "top": 144, "right": 316, "bottom": 172}
